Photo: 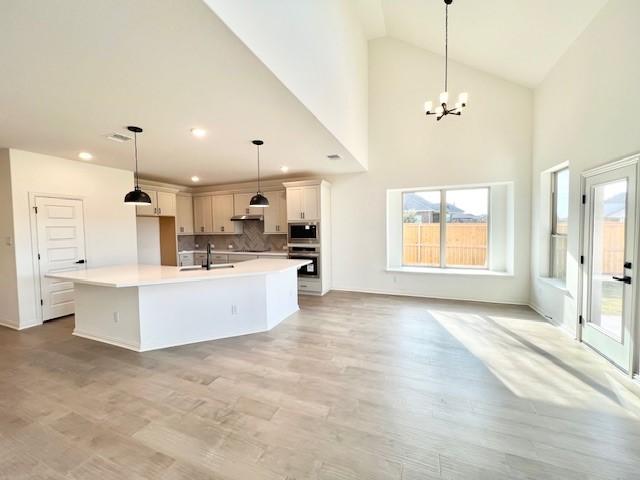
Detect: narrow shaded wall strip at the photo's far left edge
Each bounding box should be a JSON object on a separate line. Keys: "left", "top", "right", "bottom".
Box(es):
{"left": 0, "top": 149, "right": 19, "bottom": 328}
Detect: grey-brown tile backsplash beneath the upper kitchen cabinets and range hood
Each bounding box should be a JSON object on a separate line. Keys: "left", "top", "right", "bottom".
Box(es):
{"left": 178, "top": 220, "right": 287, "bottom": 251}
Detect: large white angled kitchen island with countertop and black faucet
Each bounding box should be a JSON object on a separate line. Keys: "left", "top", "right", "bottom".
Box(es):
{"left": 48, "top": 258, "right": 309, "bottom": 352}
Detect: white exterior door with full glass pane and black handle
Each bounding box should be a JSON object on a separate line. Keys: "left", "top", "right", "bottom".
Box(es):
{"left": 581, "top": 164, "right": 637, "bottom": 372}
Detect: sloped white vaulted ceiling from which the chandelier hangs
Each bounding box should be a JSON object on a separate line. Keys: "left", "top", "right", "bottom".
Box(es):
{"left": 353, "top": 0, "right": 608, "bottom": 87}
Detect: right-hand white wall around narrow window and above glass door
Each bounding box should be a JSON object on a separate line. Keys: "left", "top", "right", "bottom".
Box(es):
{"left": 531, "top": 0, "right": 640, "bottom": 335}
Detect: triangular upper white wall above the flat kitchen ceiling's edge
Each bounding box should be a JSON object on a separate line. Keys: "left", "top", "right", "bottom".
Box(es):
{"left": 205, "top": 0, "right": 367, "bottom": 167}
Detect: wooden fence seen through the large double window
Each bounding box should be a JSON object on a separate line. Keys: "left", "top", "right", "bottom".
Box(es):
{"left": 402, "top": 223, "right": 487, "bottom": 267}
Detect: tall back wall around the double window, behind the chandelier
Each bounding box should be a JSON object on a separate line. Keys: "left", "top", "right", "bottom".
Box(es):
{"left": 331, "top": 39, "right": 532, "bottom": 303}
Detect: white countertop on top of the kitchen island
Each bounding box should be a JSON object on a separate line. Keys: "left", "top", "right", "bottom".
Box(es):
{"left": 46, "top": 258, "right": 311, "bottom": 288}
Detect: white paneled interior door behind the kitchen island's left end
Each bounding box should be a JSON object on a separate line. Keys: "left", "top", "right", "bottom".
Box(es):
{"left": 35, "top": 196, "right": 86, "bottom": 321}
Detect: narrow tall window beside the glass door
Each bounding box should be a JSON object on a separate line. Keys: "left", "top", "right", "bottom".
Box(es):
{"left": 549, "top": 168, "right": 569, "bottom": 282}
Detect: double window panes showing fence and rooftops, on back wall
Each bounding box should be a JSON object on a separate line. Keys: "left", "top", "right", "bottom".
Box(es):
{"left": 402, "top": 187, "right": 489, "bottom": 269}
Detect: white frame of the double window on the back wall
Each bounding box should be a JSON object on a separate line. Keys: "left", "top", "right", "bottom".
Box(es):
{"left": 400, "top": 185, "right": 491, "bottom": 271}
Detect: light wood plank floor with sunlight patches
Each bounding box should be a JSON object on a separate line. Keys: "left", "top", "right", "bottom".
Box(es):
{"left": 0, "top": 292, "right": 640, "bottom": 480}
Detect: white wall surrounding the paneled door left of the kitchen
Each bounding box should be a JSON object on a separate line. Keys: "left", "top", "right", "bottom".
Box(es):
{"left": 9, "top": 149, "right": 137, "bottom": 328}
